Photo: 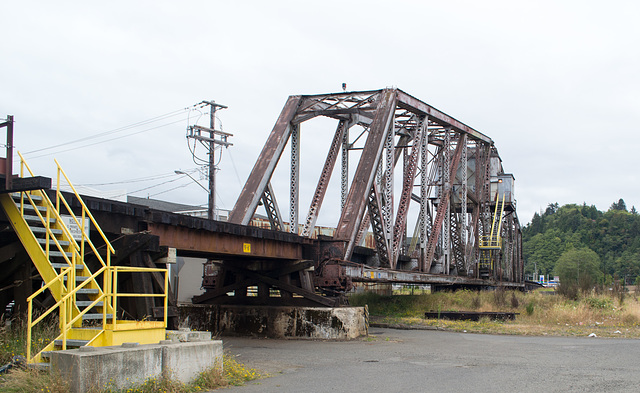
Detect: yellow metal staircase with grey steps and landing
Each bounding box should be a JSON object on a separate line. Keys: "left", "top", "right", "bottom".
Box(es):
{"left": 0, "top": 153, "right": 168, "bottom": 363}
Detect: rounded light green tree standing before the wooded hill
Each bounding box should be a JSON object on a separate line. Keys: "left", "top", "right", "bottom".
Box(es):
{"left": 555, "top": 247, "right": 601, "bottom": 290}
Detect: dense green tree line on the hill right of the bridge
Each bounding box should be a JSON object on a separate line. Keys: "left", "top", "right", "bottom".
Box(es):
{"left": 522, "top": 199, "right": 640, "bottom": 287}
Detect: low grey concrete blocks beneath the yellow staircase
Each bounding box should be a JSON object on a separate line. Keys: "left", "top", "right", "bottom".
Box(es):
{"left": 50, "top": 340, "right": 222, "bottom": 393}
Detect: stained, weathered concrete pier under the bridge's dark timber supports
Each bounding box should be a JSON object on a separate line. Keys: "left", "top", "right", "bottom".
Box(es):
{"left": 179, "top": 305, "right": 368, "bottom": 340}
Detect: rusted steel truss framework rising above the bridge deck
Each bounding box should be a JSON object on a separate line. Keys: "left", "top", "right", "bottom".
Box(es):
{"left": 229, "top": 88, "right": 522, "bottom": 283}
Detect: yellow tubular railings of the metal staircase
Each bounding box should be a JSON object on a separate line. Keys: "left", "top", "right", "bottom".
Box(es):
{"left": 18, "top": 152, "right": 169, "bottom": 362}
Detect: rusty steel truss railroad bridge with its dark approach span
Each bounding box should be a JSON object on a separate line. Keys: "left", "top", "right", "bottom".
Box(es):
{"left": 0, "top": 88, "right": 524, "bottom": 318}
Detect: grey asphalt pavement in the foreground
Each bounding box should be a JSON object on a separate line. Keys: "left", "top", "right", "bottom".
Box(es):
{"left": 223, "top": 328, "right": 640, "bottom": 393}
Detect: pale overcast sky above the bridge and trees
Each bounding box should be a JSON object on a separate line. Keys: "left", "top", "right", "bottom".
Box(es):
{"left": 0, "top": 0, "right": 640, "bottom": 225}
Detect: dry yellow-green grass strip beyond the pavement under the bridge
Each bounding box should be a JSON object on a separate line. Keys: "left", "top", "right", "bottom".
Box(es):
{"left": 358, "top": 290, "right": 640, "bottom": 338}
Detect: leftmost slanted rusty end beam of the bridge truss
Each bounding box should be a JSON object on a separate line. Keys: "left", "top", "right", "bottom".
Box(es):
{"left": 229, "top": 96, "right": 302, "bottom": 225}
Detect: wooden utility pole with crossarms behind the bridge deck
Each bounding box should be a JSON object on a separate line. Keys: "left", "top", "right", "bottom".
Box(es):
{"left": 187, "top": 100, "right": 233, "bottom": 220}
